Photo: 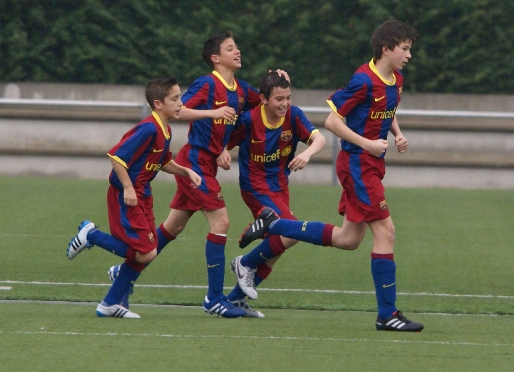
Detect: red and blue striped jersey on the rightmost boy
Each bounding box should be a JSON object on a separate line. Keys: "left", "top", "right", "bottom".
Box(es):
{"left": 327, "top": 60, "right": 403, "bottom": 157}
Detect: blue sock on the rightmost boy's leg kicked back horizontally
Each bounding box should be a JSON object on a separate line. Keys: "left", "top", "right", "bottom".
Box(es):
{"left": 268, "top": 218, "right": 334, "bottom": 246}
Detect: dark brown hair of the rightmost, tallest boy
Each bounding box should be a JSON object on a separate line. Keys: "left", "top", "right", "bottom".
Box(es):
{"left": 371, "top": 20, "right": 418, "bottom": 60}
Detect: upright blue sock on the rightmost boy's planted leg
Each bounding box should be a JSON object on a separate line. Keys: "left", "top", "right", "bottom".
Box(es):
{"left": 371, "top": 253, "right": 397, "bottom": 319}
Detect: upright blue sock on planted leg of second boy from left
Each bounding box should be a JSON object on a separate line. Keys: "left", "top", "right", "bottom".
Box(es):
{"left": 205, "top": 233, "right": 227, "bottom": 301}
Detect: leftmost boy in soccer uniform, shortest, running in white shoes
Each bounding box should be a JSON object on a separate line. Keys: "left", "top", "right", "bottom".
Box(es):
{"left": 67, "top": 78, "right": 201, "bottom": 318}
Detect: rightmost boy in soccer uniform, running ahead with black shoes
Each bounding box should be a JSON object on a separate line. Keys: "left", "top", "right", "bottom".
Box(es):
{"left": 240, "top": 21, "right": 423, "bottom": 332}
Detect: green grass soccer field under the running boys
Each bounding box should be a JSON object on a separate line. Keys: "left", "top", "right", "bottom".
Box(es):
{"left": 0, "top": 177, "right": 514, "bottom": 371}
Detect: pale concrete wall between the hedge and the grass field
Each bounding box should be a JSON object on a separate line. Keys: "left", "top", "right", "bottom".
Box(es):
{"left": 0, "top": 83, "right": 514, "bottom": 189}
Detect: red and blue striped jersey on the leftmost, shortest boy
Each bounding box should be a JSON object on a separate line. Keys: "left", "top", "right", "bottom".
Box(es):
{"left": 107, "top": 112, "right": 172, "bottom": 197}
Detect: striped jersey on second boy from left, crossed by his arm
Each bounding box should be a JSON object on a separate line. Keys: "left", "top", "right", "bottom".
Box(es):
{"left": 182, "top": 71, "right": 260, "bottom": 155}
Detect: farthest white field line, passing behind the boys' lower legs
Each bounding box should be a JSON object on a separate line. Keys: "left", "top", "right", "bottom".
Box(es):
{"left": 0, "top": 280, "right": 514, "bottom": 300}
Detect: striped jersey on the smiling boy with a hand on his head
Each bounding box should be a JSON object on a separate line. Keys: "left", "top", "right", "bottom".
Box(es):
{"left": 227, "top": 105, "right": 318, "bottom": 192}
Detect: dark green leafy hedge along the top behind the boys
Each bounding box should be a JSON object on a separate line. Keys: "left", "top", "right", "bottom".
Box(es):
{"left": 0, "top": 0, "right": 514, "bottom": 93}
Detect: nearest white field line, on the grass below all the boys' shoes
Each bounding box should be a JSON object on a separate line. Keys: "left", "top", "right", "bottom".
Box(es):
{"left": 0, "top": 330, "right": 514, "bottom": 348}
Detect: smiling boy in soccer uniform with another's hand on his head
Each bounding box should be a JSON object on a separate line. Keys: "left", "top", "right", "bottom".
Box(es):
{"left": 227, "top": 72, "right": 325, "bottom": 318}
